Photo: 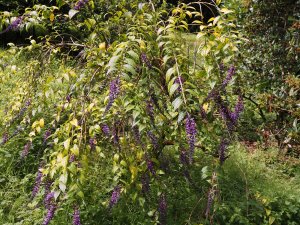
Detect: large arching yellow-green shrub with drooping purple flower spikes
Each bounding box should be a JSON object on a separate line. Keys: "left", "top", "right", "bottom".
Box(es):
{"left": 1, "top": 1, "right": 244, "bottom": 225}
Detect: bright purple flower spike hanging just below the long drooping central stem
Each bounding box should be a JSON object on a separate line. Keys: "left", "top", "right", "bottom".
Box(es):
{"left": 185, "top": 115, "right": 197, "bottom": 163}
